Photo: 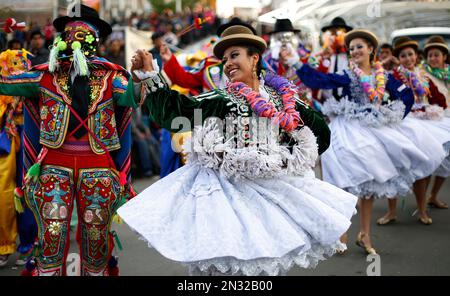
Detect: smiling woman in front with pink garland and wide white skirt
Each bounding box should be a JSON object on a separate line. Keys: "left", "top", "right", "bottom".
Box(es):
{"left": 118, "top": 25, "right": 357, "bottom": 275}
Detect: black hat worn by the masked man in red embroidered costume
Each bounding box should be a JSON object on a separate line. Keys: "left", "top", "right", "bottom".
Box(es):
{"left": 53, "top": 4, "right": 112, "bottom": 38}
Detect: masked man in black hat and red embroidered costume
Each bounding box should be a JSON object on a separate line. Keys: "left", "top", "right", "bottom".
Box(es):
{"left": 0, "top": 4, "right": 136, "bottom": 275}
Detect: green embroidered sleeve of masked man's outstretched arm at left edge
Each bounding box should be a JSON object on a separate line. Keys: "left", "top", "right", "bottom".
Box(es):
{"left": 0, "top": 72, "right": 43, "bottom": 98}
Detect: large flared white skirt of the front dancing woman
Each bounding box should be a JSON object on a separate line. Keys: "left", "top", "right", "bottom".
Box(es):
{"left": 118, "top": 163, "right": 357, "bottom": 275}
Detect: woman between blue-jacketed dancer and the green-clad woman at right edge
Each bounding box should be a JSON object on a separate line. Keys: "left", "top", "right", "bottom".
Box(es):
{"left": 377, "top": 37, "right": 450, "bottom": 225}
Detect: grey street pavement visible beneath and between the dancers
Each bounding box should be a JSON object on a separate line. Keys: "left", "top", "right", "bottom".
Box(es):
{"left": 0, "top": 170, "right": 450, "bottom": 276}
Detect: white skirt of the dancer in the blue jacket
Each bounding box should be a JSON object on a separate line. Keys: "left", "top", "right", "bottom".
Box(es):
{"left": 322, "top": 116, "right": 444, "bottom": 198}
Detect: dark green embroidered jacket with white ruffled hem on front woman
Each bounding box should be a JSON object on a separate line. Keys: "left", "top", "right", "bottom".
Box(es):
{"left": 141, "top": 72, "right": 330, "bottom": 179}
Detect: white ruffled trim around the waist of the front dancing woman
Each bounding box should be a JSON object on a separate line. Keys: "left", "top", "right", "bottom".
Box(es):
{"left": 184, "top": 123, "right": 319, "bottom": 179}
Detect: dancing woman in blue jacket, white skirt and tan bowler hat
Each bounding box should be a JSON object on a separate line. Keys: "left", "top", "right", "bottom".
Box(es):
{"left": 290, "top": 29, "right": 444, "bottom": 254}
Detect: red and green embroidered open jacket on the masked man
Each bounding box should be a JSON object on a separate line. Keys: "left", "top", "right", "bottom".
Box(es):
{"left": 0, "top": 59, "right": 136, "bottom": 154}
